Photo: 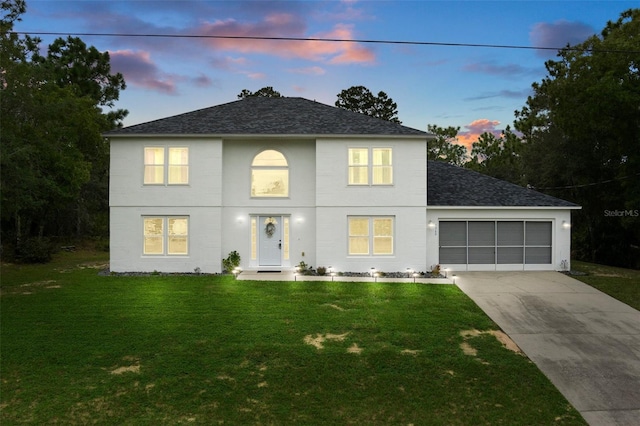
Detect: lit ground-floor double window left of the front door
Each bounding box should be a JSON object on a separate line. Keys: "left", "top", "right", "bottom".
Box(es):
{"left": 142, "top": 216, "right": 189, "bottom": 256}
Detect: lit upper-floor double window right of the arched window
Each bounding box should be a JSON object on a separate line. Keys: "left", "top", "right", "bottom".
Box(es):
{"left": 349, "top": 148, "right": 393, "bottom": 185}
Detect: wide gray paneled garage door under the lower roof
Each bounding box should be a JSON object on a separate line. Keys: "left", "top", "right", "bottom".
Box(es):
{"left": 440, "top": 220, "right": 552, "bottom": 268}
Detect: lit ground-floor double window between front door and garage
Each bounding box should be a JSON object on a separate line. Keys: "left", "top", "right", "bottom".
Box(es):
{"left": 348, "top": 216, "right": 394, "bottom": 256}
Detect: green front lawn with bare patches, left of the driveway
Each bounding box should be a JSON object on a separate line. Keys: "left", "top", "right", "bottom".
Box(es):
{"left": 0, "top": 252, "right": 585, "bottom": 425}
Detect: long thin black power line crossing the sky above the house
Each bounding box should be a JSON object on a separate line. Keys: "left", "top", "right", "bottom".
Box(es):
{"left": 13, "top": 31, "right": 640, "bottom": 53}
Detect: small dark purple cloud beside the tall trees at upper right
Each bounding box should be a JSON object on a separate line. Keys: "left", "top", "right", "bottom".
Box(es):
{"left": 529, "top": 19, "right": 596, "bottom": 58}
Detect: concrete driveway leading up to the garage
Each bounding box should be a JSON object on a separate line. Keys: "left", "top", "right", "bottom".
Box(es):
{"left": 456, "top": 272, "right": 640, "bottom": 426}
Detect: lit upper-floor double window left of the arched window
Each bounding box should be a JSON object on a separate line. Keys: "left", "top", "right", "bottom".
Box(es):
{"left": 144, "top": 146, "right": 189, "bottom": 185}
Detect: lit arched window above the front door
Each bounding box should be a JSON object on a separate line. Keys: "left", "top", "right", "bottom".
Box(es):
{"left": 251, "top": 149, "right": 289, "bottom": 197}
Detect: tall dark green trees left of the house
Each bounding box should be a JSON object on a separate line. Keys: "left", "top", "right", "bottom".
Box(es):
{"left": 0, "top": 0, "right": 127, "bottom": 261}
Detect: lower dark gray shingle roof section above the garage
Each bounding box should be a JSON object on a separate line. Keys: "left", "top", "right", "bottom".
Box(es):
{"left": 427, "top": 161, "right": 578, "bottom": 208}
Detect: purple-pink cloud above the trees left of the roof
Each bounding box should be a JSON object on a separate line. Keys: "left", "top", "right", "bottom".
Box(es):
{"left": 109, "top": 50, "right": 178, "bottom": 95}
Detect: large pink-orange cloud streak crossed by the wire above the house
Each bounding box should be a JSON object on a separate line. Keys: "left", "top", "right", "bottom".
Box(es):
{"left": 72, "top": 2, "right": 375, "bottom": 64}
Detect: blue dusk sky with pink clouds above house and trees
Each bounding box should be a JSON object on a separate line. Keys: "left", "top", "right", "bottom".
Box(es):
{"left": 14, "top": 0, "right": 638, "bottom": 148}
